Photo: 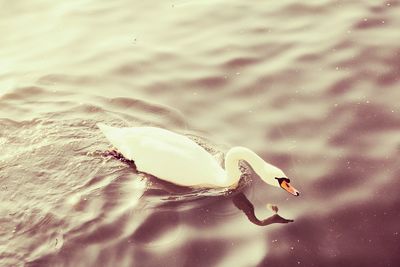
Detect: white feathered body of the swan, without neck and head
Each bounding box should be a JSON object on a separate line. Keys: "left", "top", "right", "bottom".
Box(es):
{"left": 98, "top": 123, "right": 226, "bottom": 186}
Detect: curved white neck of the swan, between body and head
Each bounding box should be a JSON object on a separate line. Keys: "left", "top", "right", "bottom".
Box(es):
{"left": 225, "top": 147, "right": 267, "bottom": 187}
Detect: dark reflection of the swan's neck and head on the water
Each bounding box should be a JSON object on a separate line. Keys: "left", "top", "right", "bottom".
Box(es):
{"left": 232, "top": 192, "right": 293, "bottom": 226}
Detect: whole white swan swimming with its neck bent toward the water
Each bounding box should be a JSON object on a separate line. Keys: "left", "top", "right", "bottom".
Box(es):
{"left": 97, "top": 123, "right": 300, "bottom": 196}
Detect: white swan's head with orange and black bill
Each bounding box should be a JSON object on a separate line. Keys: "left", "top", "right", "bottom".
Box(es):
{"left": 261, "top": 164, "right": 300, "bottom": 196}
